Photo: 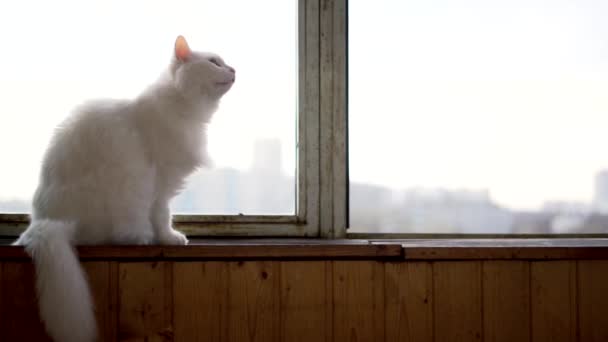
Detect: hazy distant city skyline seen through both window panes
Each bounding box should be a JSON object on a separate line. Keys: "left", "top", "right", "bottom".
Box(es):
{"left": 0, "top": 140, "right": 608, "bottom": 234}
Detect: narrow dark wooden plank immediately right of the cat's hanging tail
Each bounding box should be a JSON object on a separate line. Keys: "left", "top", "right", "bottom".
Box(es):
{"left": 82, "top": 261, "right": 118, "bottom": 341}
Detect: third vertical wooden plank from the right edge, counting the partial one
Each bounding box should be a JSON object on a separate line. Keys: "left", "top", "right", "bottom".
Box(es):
{"left": 482, "top": 261, "right": 530, "bottom": 342}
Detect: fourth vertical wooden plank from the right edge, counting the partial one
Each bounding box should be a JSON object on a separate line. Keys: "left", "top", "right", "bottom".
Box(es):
{"left": 433, "top": 261, "right": 483, "bottom": 342}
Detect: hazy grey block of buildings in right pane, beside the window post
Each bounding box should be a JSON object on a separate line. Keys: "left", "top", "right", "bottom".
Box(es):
{"left": 350, "top": 183, "right": 513, "bottom": 234}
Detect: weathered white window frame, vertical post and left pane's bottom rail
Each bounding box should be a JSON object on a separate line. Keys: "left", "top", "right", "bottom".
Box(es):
{"left": 0, "top": 0, "right": 348, "bottom": 238}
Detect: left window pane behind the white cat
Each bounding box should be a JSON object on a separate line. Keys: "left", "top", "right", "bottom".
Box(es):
{"left": 0, "top": 0, "right": 297, "bottom": 214}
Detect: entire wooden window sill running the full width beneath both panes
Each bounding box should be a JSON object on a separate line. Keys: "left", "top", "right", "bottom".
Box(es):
{"left": 0, "top": 238, "right": 608, "bottom": 261}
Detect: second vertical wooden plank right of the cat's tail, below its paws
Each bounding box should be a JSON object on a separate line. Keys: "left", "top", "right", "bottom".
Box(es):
{"left": 118, "top": 262, "right": 173, "bottom": 342}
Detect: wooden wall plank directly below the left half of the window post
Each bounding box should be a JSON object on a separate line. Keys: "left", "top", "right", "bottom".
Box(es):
{"left": 280, "top": 261, "right": 332, "bottom": 342}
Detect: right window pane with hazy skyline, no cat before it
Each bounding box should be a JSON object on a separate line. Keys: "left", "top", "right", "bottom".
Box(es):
{"left": 349, "top": 0, "right": 608, "bottom": 233}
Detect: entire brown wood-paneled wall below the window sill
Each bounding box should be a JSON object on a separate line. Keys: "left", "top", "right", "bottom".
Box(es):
{"left": 0, "top": 260, "right": 608, "bottom": 342}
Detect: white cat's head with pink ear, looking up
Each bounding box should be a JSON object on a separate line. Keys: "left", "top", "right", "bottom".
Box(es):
{"left": 171, "top": 36, "right": 235, "bottom": 101}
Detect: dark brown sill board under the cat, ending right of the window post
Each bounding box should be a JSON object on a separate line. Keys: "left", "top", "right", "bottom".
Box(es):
{"left": 0, "top": 239, "right": 403, "bottom": 260}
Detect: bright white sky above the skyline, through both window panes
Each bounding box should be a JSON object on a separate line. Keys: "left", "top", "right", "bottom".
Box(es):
{"left": 0, "top": 0, "right": 608, "bottom": 209}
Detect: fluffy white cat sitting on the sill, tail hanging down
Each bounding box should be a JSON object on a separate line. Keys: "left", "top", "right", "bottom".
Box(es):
{"left": 15, "top": 36, "right": 235, "bottom": 342}
